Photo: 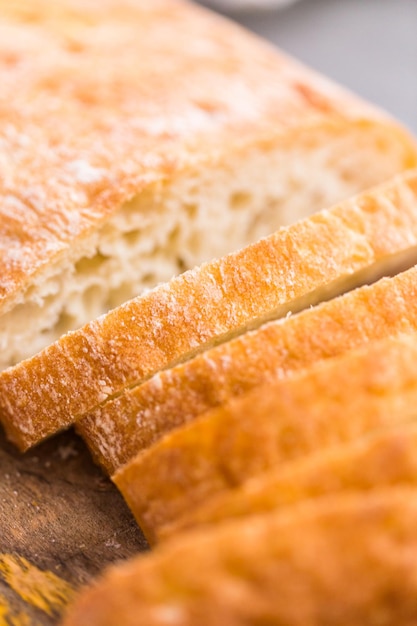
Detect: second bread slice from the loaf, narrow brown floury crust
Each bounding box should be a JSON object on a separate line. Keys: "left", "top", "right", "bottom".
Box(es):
{"left": 82, "top": 258, "right": 417, "bottom": 473}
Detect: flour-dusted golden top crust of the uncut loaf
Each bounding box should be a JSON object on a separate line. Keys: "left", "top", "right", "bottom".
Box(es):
{"left": 0, "top": 0, "right": 407, "bottom": 312}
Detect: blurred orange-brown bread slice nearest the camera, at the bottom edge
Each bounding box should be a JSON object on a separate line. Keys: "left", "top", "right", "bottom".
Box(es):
{"left": 63, "top": 489, "right": 417, "bottom": 626}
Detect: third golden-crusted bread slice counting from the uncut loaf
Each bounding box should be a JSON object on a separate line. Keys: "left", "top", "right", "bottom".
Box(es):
{"left": 113, "top": 332, "right": 417, "bottom": 541}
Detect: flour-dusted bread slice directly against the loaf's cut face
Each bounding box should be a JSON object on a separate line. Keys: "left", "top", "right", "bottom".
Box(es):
{"left": 0, "top": 170, "right": 417, "bottom": 449}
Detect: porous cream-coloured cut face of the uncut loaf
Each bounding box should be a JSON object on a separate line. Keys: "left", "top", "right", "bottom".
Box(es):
{"left": 0, "top": 124, "right": 410, "bottom": 369}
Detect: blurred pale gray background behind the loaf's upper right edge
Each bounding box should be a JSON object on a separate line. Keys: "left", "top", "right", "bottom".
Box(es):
{"left": 203, "top": 0, "right": 417, "bottom": 133}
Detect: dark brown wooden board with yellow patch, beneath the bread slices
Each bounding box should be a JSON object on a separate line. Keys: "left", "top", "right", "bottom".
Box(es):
{"left": 0, "top": 422, "right": 147, "bottom": 626}
